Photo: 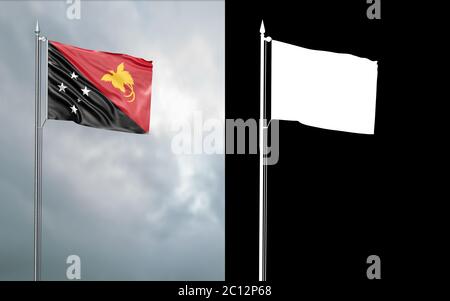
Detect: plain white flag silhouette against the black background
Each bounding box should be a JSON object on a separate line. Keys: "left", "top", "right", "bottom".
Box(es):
{"left": 271, "top": 40, "right": 378, "bottom": 134}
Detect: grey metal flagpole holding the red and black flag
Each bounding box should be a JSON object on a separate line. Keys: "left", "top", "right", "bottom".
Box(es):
{"left": 33, "top": 21, "right": 43, "bottom": 281}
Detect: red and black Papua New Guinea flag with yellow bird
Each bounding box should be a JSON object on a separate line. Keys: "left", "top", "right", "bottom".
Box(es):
{"left": 48, "top": 41, "right": 153, "bottom": 134}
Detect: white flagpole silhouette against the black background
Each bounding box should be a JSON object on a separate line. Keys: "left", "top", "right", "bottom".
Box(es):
{"left": 259, "top": 21, "right": 272, "bottom": 281}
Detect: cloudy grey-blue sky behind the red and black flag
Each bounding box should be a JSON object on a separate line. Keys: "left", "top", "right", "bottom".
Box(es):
{"left": 0, "top": 1, "right": 225, "bottom": 280}
